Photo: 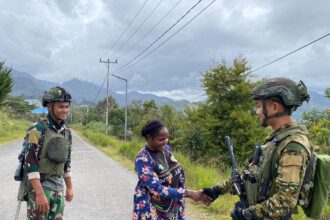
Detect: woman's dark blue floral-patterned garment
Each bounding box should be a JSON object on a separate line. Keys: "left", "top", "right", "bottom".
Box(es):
{"left": 133, "top": 145, "right": 186, "bottom": 220}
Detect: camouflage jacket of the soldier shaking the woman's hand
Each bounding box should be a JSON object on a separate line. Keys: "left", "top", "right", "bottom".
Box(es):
{"left": 218, "top": 125, "right": 309, "bottom": 219}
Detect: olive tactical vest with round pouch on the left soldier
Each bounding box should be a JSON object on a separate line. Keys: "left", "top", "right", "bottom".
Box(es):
{"left": 39, "top": 120, "right": 71, "bottom": 176}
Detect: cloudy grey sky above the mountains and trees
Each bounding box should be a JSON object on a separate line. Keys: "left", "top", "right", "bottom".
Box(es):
{"left": 0, "top": 0, "right": 330, "bottom": 100}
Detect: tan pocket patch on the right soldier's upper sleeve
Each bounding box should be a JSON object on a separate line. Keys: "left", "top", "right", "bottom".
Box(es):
{"left": 279, "top": 154, "right": 303, "bottom": 183}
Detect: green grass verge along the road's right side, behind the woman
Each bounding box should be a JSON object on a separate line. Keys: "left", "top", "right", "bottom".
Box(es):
{"left": 73, "top": 125, "right": 330, "bottom": 220}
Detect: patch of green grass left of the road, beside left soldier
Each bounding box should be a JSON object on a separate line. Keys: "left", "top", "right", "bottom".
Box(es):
{"left": 0, "top": 120, "right": 31, "bottom": 145}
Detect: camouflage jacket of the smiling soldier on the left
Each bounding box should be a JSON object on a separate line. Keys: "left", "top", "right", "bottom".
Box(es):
{"left": 23, "top": 114, "right": 72, "bottom": 179}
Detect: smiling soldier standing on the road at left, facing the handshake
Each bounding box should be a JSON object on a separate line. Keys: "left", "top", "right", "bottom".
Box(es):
{"left": 24, "top": 87, "right": 73, "bottom": 220}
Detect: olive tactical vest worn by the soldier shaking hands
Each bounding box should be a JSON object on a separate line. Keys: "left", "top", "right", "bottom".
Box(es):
{"left": 243, "top": 125, "right": 311, "bottom": 206}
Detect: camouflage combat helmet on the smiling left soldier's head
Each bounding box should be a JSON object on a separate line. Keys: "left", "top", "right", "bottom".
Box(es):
{"left": 42, "top": 86, "right": 72, "bottom": 107}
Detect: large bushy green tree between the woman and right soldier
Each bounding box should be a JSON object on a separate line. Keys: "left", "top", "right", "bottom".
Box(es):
{"left": 179, "top": 57, "right": 266, "bottom": 163}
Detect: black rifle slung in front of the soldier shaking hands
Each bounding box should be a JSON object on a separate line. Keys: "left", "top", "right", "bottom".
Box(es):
{"left": 225, "top": 136, "right": 249, "bottom": 220}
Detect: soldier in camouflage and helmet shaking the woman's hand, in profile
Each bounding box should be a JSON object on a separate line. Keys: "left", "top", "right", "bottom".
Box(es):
{"left": 204, "top": 78, "right": 312, "bottom": 219}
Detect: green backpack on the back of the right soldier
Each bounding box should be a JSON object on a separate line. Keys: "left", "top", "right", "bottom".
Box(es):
{"left": 298, "top": 152, "right": 330, "bottom": 218}
